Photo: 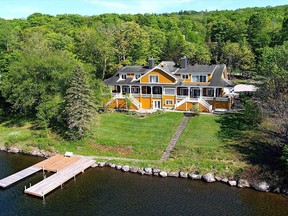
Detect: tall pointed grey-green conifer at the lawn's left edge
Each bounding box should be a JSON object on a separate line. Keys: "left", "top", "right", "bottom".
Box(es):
{"left": 65, "top": 66, "right": 97, "bottom": 139}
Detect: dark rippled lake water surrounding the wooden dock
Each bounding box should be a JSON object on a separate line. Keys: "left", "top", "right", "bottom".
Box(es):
{"left": 0, "top": 152, "right": 288, "bottom": 216}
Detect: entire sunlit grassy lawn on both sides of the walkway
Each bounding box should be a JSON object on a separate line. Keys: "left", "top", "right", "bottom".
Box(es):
{"left": 0, "top": 112, "right": 246, "bottom": 175}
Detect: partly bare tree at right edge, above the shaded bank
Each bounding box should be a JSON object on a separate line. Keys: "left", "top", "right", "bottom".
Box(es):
{"left": 257, "top": 42, "right": 288, "bottom": 145}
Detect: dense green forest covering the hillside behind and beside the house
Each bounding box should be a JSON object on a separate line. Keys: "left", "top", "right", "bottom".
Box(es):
{"left": 0, "top": 5, "right": 288, "bottom": 158}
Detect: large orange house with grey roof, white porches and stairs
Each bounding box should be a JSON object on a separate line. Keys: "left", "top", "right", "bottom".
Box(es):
{"left": 104, "top": 57, "right": 234, "bottom": 112}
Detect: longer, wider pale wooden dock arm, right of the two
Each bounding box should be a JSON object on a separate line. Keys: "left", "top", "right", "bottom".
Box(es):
{"left": 24, "top": 158, "right": 95, "bottom": 197}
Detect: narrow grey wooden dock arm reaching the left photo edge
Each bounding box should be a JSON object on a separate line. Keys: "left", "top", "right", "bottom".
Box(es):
{"left": 0, "top": 166, "right": 42, "bottom": 188}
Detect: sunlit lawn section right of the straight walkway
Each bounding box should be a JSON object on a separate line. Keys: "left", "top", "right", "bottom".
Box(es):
{"left": 165, "top": 115, "right": 246, "bottom": 176}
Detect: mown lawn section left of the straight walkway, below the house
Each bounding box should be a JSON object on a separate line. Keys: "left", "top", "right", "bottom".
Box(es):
{"left": 55, "top": 112, "right": 183, "bottom": 160}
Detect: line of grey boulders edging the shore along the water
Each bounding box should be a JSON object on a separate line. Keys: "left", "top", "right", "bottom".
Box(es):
{"left": 0, "top": 147, "right": 288, "bottom": 195}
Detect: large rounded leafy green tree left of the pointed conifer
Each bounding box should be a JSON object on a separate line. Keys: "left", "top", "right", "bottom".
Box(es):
{"left": 0, "top": 32, "right": 78, "bottom": 116}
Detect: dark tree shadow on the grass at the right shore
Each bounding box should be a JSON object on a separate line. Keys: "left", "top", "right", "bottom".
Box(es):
{"left": 217, "top": 113, "right": 287, "bottom": 184}
